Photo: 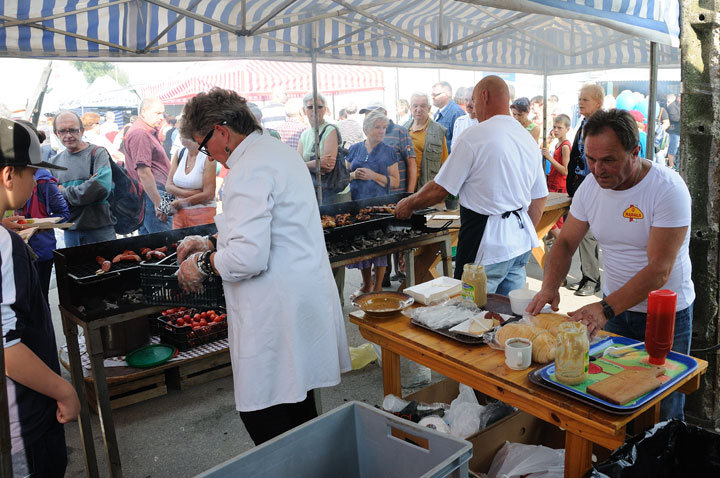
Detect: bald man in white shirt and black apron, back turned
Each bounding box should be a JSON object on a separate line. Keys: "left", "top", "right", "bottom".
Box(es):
{"left": 395, "top": 76, "right": 548, "bottom": 295}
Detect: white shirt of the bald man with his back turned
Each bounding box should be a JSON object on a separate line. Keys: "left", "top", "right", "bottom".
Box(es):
{"left": 435, "top": 115, "right": 548, "bottom": 265}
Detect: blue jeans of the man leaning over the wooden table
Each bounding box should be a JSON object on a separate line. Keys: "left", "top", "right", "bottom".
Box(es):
{"left": 605, "top": 304, "right": 693, "bottom": 421}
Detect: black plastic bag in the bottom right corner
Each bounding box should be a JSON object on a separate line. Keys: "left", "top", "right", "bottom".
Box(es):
{"left": 586, "top": 420, "right": 720, "bottom": 478}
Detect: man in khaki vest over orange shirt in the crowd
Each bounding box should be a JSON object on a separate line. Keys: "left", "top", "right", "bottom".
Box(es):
{"left": 404, "top": 93, "right": 448, "bottom": 190}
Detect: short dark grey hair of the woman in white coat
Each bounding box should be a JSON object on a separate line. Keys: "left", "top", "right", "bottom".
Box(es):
{"left": 180, "top": 87, "right": 262, "bottom": 139}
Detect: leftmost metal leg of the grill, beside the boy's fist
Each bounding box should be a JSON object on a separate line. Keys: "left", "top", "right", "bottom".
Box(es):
{"left": 60, "top": 313, "right": 100, "bottom": 478}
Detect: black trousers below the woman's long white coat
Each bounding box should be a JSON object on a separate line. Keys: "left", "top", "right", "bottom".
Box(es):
{"left": 240, "top": 390, "right": 318, "bottom": 446}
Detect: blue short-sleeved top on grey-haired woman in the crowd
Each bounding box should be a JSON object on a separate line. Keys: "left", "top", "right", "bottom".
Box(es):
{"left": 345, "top": 141, "right": 398, "bottom": 201}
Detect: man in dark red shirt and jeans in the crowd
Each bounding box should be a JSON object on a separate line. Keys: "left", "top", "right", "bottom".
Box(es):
{"left": 124, "top": 98, "right": 172, "bottom": 234}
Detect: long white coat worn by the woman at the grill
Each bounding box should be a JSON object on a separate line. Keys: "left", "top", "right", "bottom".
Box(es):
{"left": 214, "top": 132, "right": 351, "bottom": 411}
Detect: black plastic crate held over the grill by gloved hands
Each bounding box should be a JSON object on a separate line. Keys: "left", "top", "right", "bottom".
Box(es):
{"left": 140, "top": 254, "right": 225, "bottom": 308}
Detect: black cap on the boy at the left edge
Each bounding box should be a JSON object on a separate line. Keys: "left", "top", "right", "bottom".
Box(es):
{"left": 0, "top": 118, "right": 67, "bottom": 171}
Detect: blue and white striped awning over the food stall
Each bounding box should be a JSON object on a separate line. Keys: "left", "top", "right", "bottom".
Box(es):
{"left": 0, "top": 0, "right": 680, "bottom": 74}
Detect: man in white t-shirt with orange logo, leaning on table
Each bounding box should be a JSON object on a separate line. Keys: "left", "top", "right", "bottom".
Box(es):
{"left": 527, "top": 109, "right": 695, "bottom": 420}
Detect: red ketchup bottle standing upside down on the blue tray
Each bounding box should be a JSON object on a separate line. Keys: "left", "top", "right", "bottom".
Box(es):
{"left": 645, "top": 289, "right": 677, "bottom": 365}
